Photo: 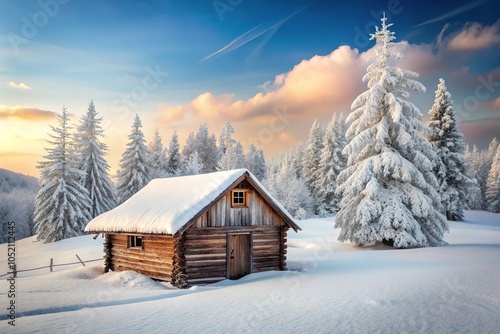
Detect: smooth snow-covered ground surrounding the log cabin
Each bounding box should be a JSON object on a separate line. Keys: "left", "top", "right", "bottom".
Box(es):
{"left": 0, "top": 211, "right": 500, "bottom": 333}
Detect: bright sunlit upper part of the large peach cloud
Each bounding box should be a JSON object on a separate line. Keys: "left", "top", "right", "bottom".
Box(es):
{"left": 159, "top": 46, "right": 368, "bottom": 122}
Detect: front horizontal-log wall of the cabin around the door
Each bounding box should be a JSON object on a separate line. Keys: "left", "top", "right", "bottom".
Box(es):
{"left": 184, "top": 225, "right": 283, "bottom": 284}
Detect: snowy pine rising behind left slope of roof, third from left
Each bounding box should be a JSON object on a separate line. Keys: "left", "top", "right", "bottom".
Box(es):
{"left": 116, "top": 115, "right": 151, "bottom": 204}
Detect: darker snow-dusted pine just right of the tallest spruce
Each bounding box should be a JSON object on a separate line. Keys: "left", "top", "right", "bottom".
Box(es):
{"left": 428, "top": 78, "right": 477, "bottom": 221}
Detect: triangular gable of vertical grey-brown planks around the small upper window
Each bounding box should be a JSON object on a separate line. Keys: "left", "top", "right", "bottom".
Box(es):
{"left": 195, "top": 181, "right": 283, "bottom": 227}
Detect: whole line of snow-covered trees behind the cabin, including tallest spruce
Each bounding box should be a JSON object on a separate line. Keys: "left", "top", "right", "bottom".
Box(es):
{"left": 28, "top": 17, "right": 500, "bottom": 248}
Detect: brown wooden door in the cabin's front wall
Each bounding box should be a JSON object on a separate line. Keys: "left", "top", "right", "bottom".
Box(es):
{"left": 227, "top": 233, "right": 252, "bottom": 279}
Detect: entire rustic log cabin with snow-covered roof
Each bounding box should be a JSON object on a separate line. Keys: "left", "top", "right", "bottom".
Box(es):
{"left": 85, "top": 169, "right": 300, "bottom": 287}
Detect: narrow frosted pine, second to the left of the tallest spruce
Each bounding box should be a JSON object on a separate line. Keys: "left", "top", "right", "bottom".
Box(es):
{"left": 302, "top": 120, "right": 325, "bottom": 211}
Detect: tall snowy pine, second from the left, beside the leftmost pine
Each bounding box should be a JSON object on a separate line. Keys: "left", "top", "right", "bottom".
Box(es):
{"left": 76, "top": 101, "right": 116, "bottom": 218}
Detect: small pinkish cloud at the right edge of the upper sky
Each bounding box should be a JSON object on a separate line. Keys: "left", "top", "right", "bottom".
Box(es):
{"left": 447, "top": 21, "right": 500, "bottom": 51}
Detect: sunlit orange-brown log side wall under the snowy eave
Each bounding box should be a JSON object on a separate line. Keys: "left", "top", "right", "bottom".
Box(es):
{"left": 107, "top": 233, "right": 174, "bottom": 281}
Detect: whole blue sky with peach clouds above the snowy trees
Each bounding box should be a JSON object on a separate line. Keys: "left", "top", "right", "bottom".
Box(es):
{"left": 0, "top": 0, "right": 500, "bottom": 174}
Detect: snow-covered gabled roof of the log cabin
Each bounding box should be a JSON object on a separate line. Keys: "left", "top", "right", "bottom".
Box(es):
{"left": 85, "top": 169, "right": 300, "bottom": 235}
